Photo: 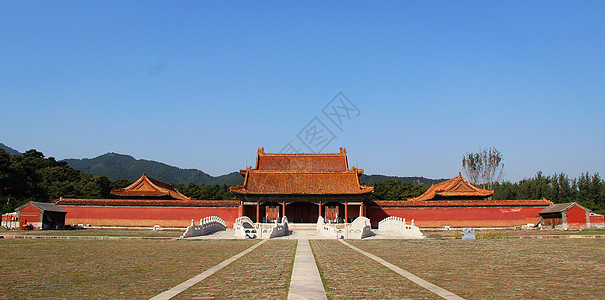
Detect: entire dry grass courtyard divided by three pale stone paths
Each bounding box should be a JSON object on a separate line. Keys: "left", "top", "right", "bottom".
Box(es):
{"left": 0, "top": 234, "right": 605, "bottom": 299}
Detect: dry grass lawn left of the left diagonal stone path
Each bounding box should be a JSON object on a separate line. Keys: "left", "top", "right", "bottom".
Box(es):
{"left": 0, "top": 239, "right": 257, "bottom": 299}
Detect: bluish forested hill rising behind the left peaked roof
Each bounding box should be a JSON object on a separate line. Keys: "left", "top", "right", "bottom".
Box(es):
{"left": 65, "top": 153, "right": 244, "bottom": 185}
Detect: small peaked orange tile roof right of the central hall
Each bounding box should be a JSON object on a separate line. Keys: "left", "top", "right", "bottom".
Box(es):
{"left": 408, "top": 173, "right": 494, "bottom": 201}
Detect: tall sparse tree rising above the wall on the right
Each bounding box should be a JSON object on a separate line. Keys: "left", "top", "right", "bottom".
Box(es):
{"left": 462, "top": 147, "right": 504, "bottom": 189}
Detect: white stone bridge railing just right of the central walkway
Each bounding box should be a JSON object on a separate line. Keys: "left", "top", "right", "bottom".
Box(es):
{"left": 317, "top": 216, "right": 372, "bottom": 239}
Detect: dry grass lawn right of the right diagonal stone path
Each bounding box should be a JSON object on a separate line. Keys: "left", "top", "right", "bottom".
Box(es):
{"left": 349, "top": 239, "right": 605, "bottom": 299}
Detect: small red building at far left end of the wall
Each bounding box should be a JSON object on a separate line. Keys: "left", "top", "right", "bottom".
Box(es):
{"left": 15, "top": 201, "right": 67, "bottom": 229}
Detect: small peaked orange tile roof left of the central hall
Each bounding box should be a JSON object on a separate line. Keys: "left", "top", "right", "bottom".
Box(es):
{"left": 111, "top": 173, "right": 191, "bottom": 200}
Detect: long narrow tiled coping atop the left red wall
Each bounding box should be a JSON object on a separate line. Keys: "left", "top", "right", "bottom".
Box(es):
{"left": 53, "top": 198, "right": 240, "bottom": 207}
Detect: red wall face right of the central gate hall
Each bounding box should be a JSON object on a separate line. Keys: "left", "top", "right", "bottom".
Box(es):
{"left": 366, "top": 206, "right": 546, "bottom": 227}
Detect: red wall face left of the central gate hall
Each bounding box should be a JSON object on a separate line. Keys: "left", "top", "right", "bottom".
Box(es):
{"left": 59, "top": 205, "right": 238, "bottom": 227}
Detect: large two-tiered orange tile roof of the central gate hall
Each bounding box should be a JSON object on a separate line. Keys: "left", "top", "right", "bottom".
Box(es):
{"left": 230, "top": 148, "right": 374, "bottom": 195}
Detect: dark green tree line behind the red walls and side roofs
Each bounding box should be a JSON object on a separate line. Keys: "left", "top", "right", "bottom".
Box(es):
{"left": 0, "top": 149, "right": 605, "bottom": 213}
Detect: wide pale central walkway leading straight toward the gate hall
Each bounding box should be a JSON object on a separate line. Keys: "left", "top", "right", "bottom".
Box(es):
{"left": 288, "top": 239, "right": 328, "bottom": 299}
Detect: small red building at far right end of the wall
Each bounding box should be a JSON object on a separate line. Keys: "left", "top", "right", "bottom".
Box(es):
{"left": 540, "top": 202, "right": 603, "bottom": 229}
